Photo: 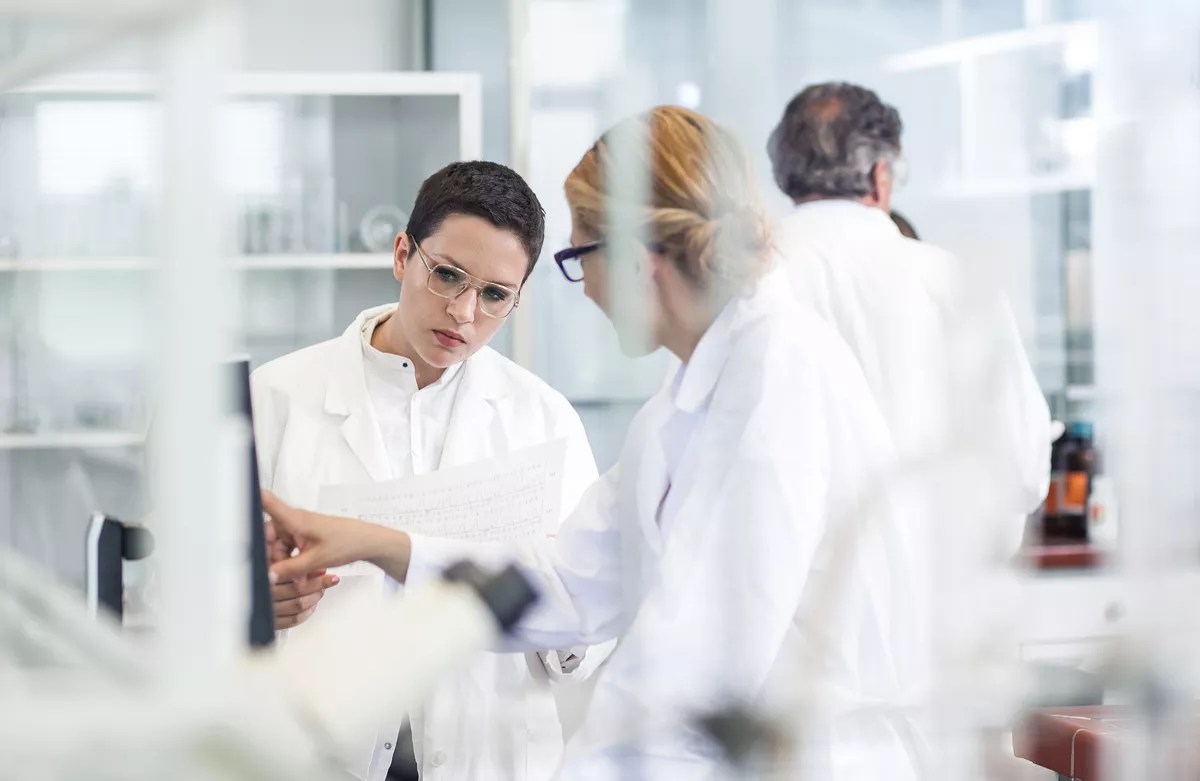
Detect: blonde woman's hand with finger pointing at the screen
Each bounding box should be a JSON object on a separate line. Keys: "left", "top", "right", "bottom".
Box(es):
{"left": 263, "top": 491, "right": 409, "bottom": 584}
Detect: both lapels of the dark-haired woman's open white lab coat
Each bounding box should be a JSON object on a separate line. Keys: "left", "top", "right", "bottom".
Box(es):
{"left": 325, "top": 304, "right": 511, "bottom": 481}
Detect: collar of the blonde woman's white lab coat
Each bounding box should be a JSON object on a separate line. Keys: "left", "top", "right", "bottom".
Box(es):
{"left": 671, "top": 268, "right": 791, "bottom": 413}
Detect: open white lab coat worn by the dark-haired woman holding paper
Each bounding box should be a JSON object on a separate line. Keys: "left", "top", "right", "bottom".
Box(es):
{"left": 251, "top": 305, "right": 606, "bottom": 781}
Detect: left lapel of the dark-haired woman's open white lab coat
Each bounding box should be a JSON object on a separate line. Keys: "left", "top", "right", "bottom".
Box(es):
{"left": 325, "top": 304, "right": 396, "bottom": 481}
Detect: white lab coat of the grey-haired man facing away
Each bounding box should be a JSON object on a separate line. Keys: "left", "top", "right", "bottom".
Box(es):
{"left": 775, "top": 199, "right": 1052, "bottom": 553}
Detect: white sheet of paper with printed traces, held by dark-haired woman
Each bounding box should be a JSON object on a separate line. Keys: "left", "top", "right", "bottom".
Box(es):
{"left": 318, "top": 439, "right": 566, "bottom": 542}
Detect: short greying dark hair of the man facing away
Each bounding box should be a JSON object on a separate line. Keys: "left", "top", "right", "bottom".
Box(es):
{"left": 767, "top": 82, "right": 902, "bottom": 200}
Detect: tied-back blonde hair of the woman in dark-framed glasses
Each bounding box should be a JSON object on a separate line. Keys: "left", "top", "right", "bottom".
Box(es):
{"left": 564, "top": 106, "right": 770, "bottom": 292}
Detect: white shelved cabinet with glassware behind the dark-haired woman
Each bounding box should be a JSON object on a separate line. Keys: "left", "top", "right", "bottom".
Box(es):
{"left": 0, "top": 72, "right": 481, "bottom": 582}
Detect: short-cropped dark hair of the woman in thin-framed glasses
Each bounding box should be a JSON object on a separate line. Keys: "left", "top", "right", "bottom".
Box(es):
{"left": 406, "top": 160, "right": 546, "bottom": 280}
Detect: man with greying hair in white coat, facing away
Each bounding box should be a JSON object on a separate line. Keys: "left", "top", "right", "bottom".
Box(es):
{"left": 768, "top": 83, "right": 1050, "bottom": 554}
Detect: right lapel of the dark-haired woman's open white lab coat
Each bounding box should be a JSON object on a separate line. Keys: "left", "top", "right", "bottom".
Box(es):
{"left": 439, "top": 348, "right": 508, "bottom": 468}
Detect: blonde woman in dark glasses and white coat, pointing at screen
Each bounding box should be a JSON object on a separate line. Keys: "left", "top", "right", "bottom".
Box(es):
{"left": 266, "top": 107, "right": 916, "bottom": 781}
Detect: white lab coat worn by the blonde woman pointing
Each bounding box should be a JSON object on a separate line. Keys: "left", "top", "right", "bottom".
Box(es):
{"left": 408, "top": 271, "right": 926, "bottom": 781}
